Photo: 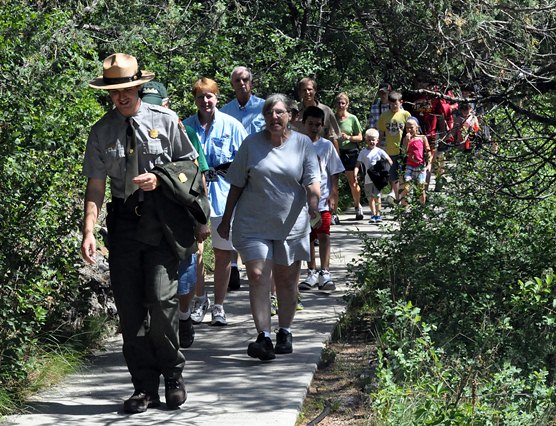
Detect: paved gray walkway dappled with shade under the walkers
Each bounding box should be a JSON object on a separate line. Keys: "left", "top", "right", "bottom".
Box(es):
{"left": 2, "top": 209, "right": 388, "bottom": 426}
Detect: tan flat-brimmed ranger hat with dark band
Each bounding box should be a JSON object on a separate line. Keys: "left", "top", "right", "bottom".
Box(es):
{"left": 89, "top": 53, "right": 154, "bottom": 90}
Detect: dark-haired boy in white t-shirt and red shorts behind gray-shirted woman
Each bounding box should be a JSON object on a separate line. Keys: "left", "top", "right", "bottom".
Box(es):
{"left": 299, "top": 106, "right": 344, "bottom": 290}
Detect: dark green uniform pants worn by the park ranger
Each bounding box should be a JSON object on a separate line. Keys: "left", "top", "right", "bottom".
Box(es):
{"left": 107, "top": 200, "right": 185, "bottom": 394}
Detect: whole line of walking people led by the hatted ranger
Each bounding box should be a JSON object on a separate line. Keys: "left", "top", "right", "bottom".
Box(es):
{"left": 81, "top": 53, "right": 482, "bottom": 413}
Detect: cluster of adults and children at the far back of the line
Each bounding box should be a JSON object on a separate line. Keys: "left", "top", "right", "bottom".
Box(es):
{"left": 354, "top": 79, "right": 479, "bottom": 223}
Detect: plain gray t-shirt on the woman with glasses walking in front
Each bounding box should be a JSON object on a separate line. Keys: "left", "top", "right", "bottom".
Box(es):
{"left": 226, "top": 131, "right": 320, "bottom": 241}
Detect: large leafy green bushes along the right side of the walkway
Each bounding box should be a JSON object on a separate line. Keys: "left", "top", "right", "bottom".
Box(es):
{"left": 357, "top": 131, "right": 556, "bottom": 425}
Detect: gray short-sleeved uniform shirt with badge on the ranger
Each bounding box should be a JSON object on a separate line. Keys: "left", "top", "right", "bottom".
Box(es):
{"left": 83, "top": 102, "right": 198, "bottom": 198}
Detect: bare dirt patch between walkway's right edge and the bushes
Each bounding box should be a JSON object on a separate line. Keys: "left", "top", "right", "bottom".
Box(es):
{"left": 297, "top": 314, "right": 375, "bottom": 426}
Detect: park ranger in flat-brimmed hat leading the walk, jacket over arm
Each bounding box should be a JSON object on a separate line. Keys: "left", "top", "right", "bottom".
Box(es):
{"left": 81, "top": 53, "right": 205, "bottom": 413}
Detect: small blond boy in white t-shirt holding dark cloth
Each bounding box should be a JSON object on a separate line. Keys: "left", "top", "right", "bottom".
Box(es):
{"left": 353, "top": 129, "right": 392, "bottom": 223}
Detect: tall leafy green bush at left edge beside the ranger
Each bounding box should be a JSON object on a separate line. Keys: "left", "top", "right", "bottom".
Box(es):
{"left": 0, "top": 2, "right": 101, "bottom": 398}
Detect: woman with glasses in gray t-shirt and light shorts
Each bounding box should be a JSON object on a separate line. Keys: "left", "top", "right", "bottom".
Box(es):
{"left": 218, "top": 94, "right": 320, "bottom": 361}
